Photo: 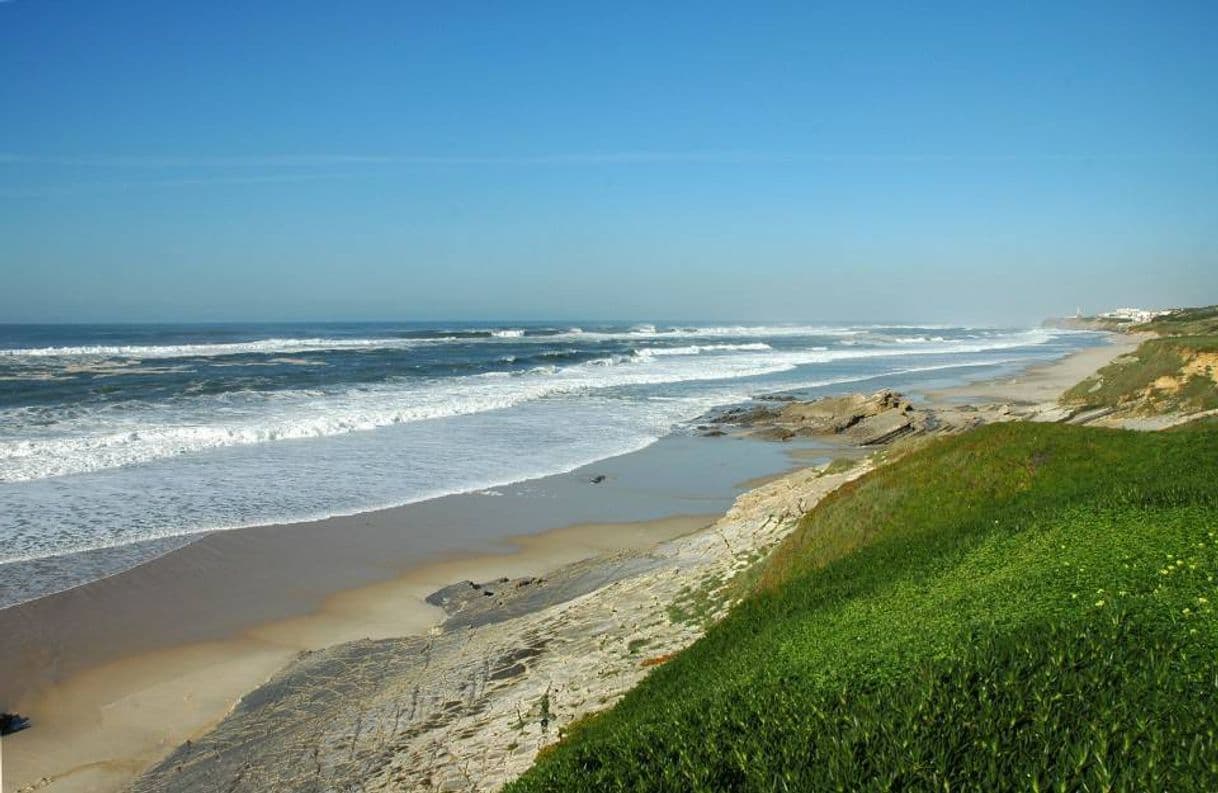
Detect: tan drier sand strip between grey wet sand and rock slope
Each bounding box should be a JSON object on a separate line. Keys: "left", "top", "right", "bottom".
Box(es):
{"left": 5, "top": 515, "right": 714, "bottom": 791}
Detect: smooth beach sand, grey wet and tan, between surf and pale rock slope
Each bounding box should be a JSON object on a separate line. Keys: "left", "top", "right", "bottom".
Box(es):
{"left": 0, "top": 435, "right": 823, "bottom": 791}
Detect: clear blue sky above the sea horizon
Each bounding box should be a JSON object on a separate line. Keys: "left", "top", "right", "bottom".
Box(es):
{"left": 0, "top": 0, "right": 1218, "bottom": 322}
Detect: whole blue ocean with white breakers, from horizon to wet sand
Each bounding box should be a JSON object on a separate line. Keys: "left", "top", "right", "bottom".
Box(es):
{"left": 0, "top": 323, "right": 1099, "bottom": 607}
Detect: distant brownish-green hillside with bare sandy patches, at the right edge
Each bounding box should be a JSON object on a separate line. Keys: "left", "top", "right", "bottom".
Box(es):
{"left": 1062, "top": 335, "right": 1218, "bottom": 414}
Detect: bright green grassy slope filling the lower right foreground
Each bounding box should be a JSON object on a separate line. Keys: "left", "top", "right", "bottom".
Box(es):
{"left": 509, "top": 424, "right": 1218, "bottom": 792}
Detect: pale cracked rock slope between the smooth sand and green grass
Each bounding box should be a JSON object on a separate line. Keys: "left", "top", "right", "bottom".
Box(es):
{"left": 140, "top": 453, "right": 870, "bottom": 793}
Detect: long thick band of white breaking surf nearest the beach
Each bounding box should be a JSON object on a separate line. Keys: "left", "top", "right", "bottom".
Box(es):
{"left": 0, "top": 330, "right": 1051, "bottom": 482}
